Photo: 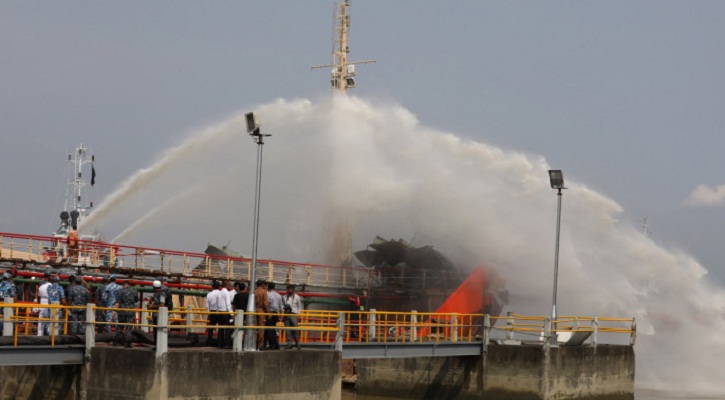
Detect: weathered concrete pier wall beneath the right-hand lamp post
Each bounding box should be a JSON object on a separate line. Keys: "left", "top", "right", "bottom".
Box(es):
{"left": 356, "top": 345, "right": 635, "bottom": 400}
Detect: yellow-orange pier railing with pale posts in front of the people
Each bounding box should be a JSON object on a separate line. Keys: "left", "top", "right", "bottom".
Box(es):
{"left": 0, "top": 299, "right": 636, "bottom": 354}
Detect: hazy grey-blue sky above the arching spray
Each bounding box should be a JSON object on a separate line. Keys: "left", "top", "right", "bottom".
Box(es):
{"left": 0, "top": 0, "right": 725, "bottom": 280}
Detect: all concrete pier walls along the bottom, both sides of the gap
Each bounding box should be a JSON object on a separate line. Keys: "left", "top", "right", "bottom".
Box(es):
{"left": 0, "top": 344, "right": 635, "bottom": 400}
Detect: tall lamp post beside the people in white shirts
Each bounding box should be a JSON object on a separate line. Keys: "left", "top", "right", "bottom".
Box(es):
{"left": 243, "top": 112, "right": 272, "bottom": 351}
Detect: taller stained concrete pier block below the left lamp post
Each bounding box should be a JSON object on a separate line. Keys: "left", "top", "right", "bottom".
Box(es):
{"left": 86, "top": 347, "right": 342, "bottom": 400}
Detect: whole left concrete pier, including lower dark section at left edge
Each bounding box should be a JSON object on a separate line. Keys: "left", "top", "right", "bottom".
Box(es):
{"left": 0, "top": 346, "right": 342, "bottom": 400}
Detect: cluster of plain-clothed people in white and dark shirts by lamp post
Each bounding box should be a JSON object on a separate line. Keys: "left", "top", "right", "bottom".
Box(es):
{"left": 206, "top": 280, "right": 302, "bottom": 350}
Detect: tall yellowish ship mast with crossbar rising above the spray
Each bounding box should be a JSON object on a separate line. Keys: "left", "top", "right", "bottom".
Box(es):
{"left": 312, "top": 0, "right": 376, "bottom": 93}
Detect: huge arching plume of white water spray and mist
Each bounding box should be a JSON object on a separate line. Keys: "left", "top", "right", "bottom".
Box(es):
{"left": 84, "top": 96, "right": 725, "bottom": 390}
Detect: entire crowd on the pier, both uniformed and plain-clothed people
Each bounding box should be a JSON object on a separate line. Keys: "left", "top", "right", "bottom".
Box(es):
{"left": 0, "top": 271, "right": 303, "bottom": 351}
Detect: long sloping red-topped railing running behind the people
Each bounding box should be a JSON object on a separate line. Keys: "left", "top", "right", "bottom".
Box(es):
{"left": 0, "top": 232, "right": 436, "bottom": 290}
